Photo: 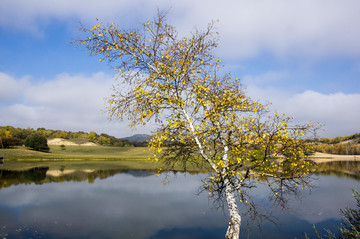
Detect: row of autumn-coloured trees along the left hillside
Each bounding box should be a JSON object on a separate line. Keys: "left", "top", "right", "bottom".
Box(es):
{"left": 0, "top": 126, "right": 147, "bottom": 148}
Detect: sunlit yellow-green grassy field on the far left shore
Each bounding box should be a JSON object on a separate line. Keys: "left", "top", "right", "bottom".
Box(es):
{"left": 0, "top": 145, "right": 208, "bottom": 172}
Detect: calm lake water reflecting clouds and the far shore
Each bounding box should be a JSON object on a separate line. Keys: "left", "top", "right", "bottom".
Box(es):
{"left": 0, "top": 162, "right": 360, "bottom": 238}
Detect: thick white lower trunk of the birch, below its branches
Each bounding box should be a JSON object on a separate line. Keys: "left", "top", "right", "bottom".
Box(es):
{"left": 225, "top": 180, "right": 241, "bottom": 239}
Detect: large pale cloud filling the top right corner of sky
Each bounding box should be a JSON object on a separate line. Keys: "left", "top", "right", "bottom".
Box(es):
{"left": 170, "top": 0, "right": 360, "bottom": 58}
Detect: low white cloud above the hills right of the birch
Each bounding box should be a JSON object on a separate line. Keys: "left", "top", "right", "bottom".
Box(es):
{"left": 247, "top": 85, "right": 360, "bottom": 137}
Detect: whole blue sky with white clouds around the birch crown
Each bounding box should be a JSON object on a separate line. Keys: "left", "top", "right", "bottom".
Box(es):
{"left": 0, "top": 0, "right": 360, "bottom": 137}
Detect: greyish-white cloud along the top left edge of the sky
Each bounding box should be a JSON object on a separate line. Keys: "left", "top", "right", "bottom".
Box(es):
{"left": 0, "top": 0, "right": 152, "bottom": 35}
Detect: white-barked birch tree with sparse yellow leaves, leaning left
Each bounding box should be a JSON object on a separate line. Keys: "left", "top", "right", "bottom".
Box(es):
{"left": 75, "top": 12, "right": 313, "bottom": 238}
